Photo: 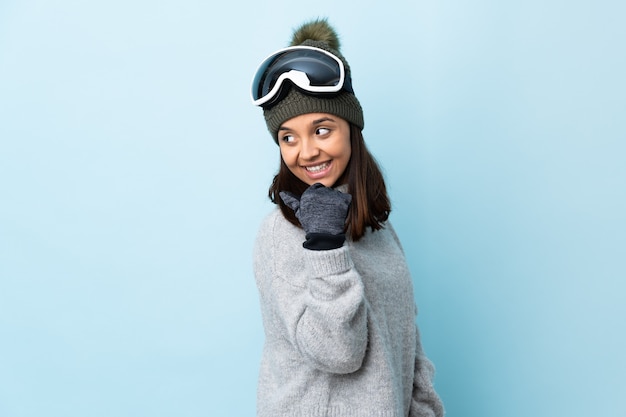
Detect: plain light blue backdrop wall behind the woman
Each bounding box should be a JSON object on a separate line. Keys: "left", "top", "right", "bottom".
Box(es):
{"left": 0, "top": 0, "right": 626, "bottom": 417}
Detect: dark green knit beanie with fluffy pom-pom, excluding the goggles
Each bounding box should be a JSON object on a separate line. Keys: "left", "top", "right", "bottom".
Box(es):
{"left": 263, "top": 19, "right": 364, "bottom": 143}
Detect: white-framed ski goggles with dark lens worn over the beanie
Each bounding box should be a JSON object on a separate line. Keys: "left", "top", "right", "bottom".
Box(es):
{"left": 252, "top": 46, "right": 353, "bottom": 106}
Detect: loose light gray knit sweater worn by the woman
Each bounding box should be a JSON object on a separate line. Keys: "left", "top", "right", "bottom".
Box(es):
{"left": 254, "top": 209, "right": 443, "bottom": 417}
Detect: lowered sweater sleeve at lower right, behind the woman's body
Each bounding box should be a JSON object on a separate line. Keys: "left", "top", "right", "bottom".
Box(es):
{"left": 409, "top": 327, "right": 444, "bottom": 417}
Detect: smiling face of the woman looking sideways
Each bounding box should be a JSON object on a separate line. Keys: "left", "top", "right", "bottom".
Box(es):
{"left": 278, "top": 113, "right": 352, "bottom": 187}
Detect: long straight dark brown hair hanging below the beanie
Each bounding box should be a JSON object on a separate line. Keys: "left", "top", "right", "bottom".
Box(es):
{"left": 268, "top": 124, "right": 391, "bottom": 241}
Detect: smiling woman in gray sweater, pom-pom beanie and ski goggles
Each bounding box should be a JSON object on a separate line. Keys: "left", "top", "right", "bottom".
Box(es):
{"left": 252, "top": 20, "right": 443, "bottom": 417}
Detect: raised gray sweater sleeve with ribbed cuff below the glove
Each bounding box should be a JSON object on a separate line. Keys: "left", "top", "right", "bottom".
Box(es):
{"left": 257, "top": 211, "right": 368, "bottom": 374}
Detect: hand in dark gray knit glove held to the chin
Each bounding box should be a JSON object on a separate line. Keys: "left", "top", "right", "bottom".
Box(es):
{"left": 279, "top": 183, "right": 352, "bottom": 250}
